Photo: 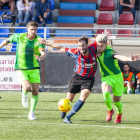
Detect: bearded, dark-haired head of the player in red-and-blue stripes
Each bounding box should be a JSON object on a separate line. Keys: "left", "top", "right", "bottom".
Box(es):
{"left": 77, "top": 36, "right": 88, "bottom": 54}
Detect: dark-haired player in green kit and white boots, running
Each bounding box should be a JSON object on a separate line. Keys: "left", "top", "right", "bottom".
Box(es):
{"left": 0, "top": 20, "right": 46, "bottom": 120}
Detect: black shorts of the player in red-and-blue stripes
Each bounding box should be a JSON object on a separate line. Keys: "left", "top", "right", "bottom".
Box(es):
{"left": 68, "top": 73, "right": 95, "bottom": 94}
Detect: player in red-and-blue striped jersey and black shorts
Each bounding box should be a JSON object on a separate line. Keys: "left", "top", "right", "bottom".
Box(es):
{"left": 39, "top": 36, "right": 97, "bottom": 123}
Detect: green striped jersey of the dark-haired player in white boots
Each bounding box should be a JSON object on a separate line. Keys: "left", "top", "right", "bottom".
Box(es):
{"left": 9, "top": 33, "right": 45, "bottom": 70}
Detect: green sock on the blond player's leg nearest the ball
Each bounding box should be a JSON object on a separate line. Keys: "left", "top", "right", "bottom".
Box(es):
{"left": 103, "top": 92, "right": 112, "bottom": 111}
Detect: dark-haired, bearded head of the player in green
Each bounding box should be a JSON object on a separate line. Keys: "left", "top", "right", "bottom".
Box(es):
{"left": 27, "top": 20, "right": 38, "bottom": 38}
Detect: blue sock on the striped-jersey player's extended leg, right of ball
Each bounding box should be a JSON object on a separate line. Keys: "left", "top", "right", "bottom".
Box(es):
{"left": 66, "top": 99, "right": 85, "bottom": 119}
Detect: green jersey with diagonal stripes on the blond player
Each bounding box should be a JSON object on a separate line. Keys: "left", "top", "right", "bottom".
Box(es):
{"left": 97, "top": 45, "right": 121, "bottom": 76}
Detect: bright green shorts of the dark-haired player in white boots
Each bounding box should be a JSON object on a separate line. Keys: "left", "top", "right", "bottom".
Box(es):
{"left": 16, "top": 69, "right": 40, "bottom": 84}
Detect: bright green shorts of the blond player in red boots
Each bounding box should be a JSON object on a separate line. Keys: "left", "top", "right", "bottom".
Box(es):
{"left": 101, "top": 73, "right": 124, "bottom": 96}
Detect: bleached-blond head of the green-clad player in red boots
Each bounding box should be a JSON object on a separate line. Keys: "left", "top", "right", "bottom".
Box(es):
{"left": 96, "top": 34, "right": 107, "bottom": 53}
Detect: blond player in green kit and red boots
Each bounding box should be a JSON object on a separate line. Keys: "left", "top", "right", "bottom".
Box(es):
{"left": 95, "top": 34, "right": 140, "bottom": 123}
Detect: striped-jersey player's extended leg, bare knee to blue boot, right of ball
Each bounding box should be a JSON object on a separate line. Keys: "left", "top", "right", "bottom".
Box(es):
{"left": 64, "top": 89, "right": 90, "bottom": 123}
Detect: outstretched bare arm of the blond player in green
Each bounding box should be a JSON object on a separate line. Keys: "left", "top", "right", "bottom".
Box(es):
{"left": 114, "top": 53, "right": 140, "bottom": 61}
